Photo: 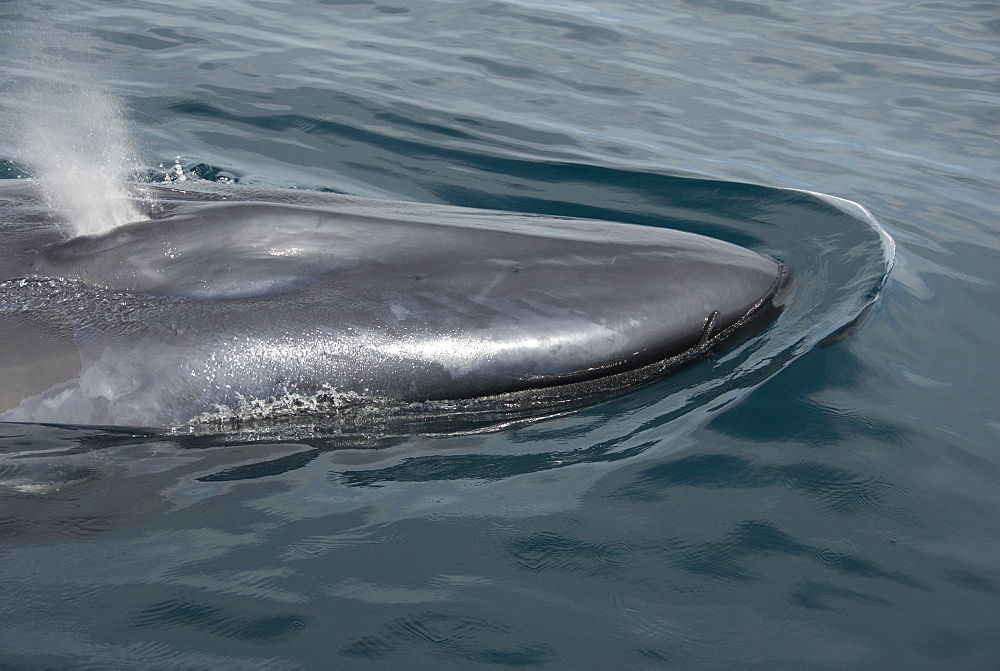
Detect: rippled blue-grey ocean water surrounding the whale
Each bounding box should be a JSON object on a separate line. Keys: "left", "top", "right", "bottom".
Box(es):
{"left": 0, "top": 0, "right": 1000, "bottom": 669}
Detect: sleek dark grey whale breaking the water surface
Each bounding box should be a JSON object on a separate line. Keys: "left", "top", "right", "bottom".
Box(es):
{"left": 0, "top": 180, "right": 790, "bottom": 431}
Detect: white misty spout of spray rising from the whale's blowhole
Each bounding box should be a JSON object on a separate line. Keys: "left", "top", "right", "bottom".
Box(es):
{"left": 4, "top": 16, "right": 153, "bottom": 236}
